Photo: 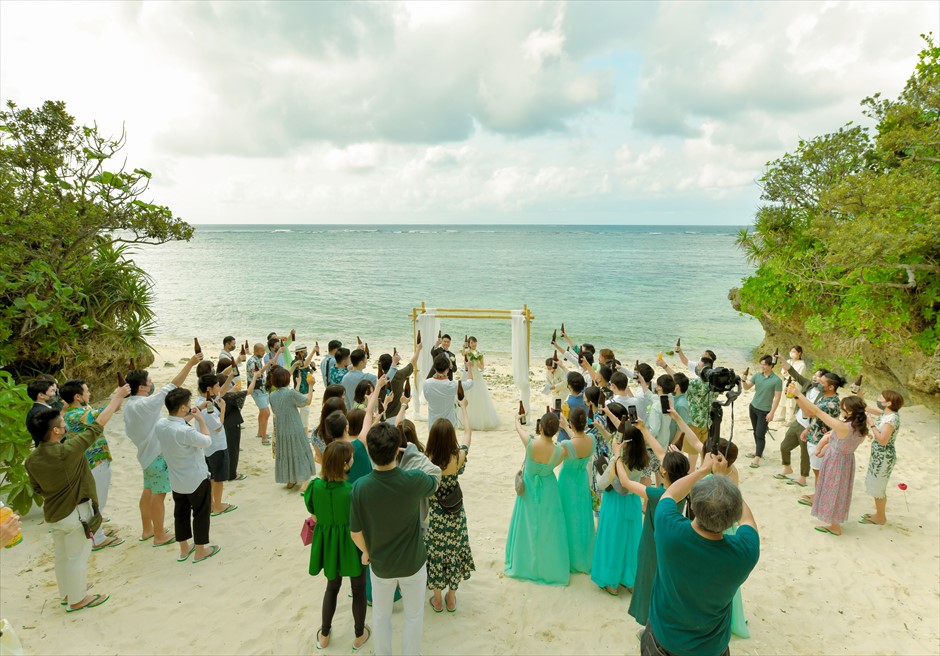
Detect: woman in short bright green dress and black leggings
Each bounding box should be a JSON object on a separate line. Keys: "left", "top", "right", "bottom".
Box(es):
{"left": 304, "top": 441, "right": 369, "bottom": 649}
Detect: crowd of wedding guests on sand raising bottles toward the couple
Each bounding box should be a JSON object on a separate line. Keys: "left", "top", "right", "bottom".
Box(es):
{"left": 9, "top": 327, "right": 903, "bottom": 654}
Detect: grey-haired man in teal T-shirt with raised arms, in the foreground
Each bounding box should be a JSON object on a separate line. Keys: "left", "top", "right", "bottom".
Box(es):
{"left": 640, "top": 453, "right": 760, "bottom": 656}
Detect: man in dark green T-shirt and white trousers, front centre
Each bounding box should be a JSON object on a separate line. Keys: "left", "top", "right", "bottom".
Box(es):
{"left": 349, "top": 422, "right": 441, "bottom": 656}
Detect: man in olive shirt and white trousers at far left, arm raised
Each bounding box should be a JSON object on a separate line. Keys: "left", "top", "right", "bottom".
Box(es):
{"left": 24, "top": 385, "right": 131, "bottom": 612}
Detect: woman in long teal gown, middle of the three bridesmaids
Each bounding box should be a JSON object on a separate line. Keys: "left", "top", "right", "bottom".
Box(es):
{"left": 558, "top": 407, "right": 594, "bottom": 574}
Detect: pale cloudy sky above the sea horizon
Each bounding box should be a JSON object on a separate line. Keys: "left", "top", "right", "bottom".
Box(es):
{"left": 0, "top": 0, "right": 940, "bottom": 225}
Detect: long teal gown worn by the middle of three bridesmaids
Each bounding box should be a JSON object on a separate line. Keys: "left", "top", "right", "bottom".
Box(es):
{"left": 558, "top": 440, "right": 594, "bottom": 574}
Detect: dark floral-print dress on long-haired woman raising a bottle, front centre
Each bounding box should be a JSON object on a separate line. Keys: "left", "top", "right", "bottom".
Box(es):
{"left": 424, "top": 445, "right": 476, "bottom": 590}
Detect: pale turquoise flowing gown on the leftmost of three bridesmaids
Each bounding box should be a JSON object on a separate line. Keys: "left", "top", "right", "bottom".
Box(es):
{"left": 506, "top": 438, "right": 570, "bottom": 585}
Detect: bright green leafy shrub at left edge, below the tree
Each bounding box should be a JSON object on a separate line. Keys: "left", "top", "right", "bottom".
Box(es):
{"left": 0, "top": 371, "right": 42, "bottom": 515}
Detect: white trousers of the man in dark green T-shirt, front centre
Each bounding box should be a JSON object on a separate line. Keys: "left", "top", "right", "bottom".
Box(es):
{"left": 369, "top": 564, "right": 428, "bottom": 656}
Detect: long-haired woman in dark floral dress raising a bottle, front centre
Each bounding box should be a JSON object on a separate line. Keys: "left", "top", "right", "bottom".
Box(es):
{"left": 424, "top": 398, "right": 476, "bottom": 613}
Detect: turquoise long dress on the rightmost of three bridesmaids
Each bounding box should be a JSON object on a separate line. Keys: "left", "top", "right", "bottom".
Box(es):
{"left": 591, "top": 463, "right": 643, "bottom": 588}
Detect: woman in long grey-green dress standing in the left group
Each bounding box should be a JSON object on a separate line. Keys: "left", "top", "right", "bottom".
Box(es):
{"left": 270, "top": 366, "right": 317, "bottom": 490}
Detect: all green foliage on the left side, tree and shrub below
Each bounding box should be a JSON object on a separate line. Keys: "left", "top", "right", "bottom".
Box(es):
{"left": 0, "top": 101, "right": 193, "bottom": 510}
